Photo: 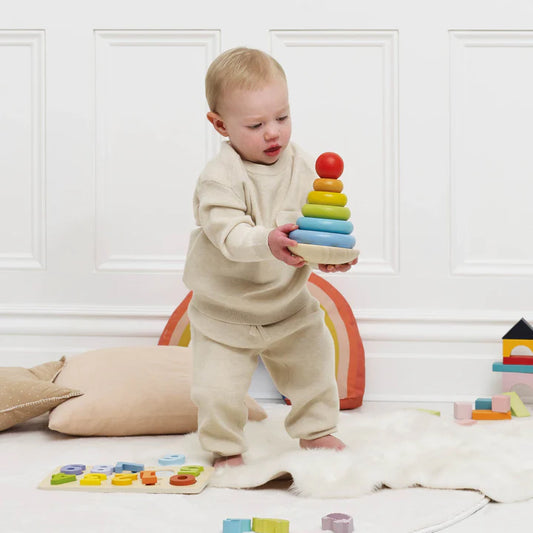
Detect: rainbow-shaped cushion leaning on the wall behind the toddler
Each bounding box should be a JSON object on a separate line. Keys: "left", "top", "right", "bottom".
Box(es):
{"left": 158, "top": 273, "right": 365, "bottom": 409}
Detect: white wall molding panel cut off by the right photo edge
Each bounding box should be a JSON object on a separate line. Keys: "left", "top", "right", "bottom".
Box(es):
{"left": 449, "top": 30, "right": 533, "bottom": 276}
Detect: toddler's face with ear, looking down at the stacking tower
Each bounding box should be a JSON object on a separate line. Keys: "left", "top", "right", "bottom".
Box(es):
{"left": 207, "top": 79, "right": 291, "bottom": 165}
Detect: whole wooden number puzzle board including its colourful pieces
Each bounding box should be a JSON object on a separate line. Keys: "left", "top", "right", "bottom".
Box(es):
{"left": 39, "top": 462, "right": 212, "bottom": 494}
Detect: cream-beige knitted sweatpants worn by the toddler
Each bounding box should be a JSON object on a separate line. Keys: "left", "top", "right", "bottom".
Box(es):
{"left": 188, "top": 299, "right": 339, "bottom": 456}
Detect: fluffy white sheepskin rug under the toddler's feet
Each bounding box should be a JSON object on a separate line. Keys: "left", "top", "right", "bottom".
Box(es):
{"left": 178, "top": 406, "right": 533, "bottom": 502}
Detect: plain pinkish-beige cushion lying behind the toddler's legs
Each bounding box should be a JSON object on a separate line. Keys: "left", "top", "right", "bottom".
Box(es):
{"left": 48, "top": 346, "right": 266, "bottom": 436}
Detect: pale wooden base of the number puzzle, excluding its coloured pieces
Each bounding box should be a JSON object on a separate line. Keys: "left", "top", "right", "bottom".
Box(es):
{"left": 38, "top": 465, "right": 213, "bottom": 494}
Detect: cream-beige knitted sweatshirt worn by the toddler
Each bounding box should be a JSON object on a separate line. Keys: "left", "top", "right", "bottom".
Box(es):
{"left": 183, "top": 142, "right": 317, "bottom": 325}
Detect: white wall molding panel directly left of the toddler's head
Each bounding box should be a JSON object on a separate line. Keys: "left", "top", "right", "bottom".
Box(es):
{"left": 94, "top": 30, "right": 220, "bottom": 272}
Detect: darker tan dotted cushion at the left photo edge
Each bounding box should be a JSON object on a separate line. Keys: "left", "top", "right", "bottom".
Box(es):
{"left": 0, "top": 358, "right": 81, "bottom": 431}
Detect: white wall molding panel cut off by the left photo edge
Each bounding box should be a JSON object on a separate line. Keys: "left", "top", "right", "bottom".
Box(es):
{"left": 0, "top": 30, "right": 46, "bottom": 270}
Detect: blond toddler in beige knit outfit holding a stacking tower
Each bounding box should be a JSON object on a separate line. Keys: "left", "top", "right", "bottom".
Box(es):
{"left": 184, "top": 48, "right": 356, "bottom": 467}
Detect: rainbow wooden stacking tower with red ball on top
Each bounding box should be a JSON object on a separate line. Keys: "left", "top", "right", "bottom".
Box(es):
{"left": 289, "top": 152, "right": 359, "bottom": 265}
